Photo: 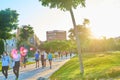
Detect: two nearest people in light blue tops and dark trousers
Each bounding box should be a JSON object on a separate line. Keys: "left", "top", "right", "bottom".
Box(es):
{"left": 1, "top": 52, "right": 21, "bottom": 80}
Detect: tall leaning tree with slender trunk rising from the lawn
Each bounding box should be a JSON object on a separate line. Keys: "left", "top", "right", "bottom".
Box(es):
{"left": 39, "top": 0, "right": 85, "bottom": 75}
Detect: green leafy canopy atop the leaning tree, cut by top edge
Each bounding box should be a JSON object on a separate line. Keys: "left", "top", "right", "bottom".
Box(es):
{"left": 39, "top": 0, "right": 85, "bottom": 10}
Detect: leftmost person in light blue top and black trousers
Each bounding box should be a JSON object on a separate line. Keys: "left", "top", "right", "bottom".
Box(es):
{"left": 1, "top": 52, "right": 10, "bottom": 80}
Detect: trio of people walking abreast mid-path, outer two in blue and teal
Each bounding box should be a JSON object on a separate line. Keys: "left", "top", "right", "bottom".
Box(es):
{"left": 34, "top": 50, "right": 52, "bottom": 69}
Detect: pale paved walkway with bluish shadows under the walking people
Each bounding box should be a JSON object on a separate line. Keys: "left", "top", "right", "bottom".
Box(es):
{"left": 0, "top": 57, "right": 72, "bottom": 80}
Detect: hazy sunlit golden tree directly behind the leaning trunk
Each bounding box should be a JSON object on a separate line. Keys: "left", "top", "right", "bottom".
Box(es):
{"left": 69, "top": 19, "right": 91, "bottom": 50}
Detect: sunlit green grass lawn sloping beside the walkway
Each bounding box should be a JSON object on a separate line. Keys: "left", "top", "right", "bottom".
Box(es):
{"left": 50, "top": 52, "right": 120, "bottom": 80}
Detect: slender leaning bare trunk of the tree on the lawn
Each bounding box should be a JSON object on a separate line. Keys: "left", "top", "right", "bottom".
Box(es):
{"left": 70, "top": 8, "right": 84, "bottom": 75}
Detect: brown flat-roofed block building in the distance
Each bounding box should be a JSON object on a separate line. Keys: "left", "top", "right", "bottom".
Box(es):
{"left": 46, "top": 30, "right": 66, "bottom": 41}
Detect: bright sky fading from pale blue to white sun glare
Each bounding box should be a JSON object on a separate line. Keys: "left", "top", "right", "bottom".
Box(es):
{"left": 0, "top": 0, "right": 120, "bottom": 41}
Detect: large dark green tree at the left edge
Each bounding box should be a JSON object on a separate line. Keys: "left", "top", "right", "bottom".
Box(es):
{"left": 0, "top": 8, "right": 19, "bottom": 52}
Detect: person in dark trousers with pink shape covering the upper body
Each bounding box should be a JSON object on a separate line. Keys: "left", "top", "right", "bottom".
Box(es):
{"left": 11, "top": 50, "right": 21, "bottom": 80}
